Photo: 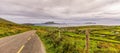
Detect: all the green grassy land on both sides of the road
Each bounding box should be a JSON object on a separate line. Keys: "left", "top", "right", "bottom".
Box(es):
{"left": 0, "top": 19, "right": 120, "bottom": 53}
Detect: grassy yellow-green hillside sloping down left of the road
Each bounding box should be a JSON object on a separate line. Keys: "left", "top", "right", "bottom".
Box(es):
{"left": 0, "top": 18, "right": 30, "bottom": 38}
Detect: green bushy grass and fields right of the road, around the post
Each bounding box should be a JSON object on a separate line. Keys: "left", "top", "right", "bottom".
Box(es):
{"left": 37, "top": 26, "right": 120, "bottom": 53}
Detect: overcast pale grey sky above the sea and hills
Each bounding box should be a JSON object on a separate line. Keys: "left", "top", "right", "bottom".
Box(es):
{"left": 0, "top": 0, "right": 120, "bottom": 23}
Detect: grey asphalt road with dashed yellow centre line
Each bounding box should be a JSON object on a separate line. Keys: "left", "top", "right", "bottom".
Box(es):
{"left": 0, "top": 30, "right": 46, "bottom": 53}
